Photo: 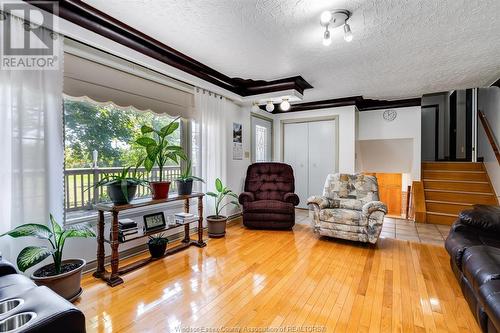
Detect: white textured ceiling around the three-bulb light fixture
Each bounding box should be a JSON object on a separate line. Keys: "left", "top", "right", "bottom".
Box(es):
{"left": 84, "top": 0, "right": 500, "bottom": 101}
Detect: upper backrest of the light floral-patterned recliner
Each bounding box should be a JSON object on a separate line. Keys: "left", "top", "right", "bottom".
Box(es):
{"left": 323, "top": 173, "right": 379, "bottom": 203}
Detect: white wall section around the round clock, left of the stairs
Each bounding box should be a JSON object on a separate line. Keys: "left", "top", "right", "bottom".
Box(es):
{"left": 358, "top": 106, "right": 421, "bottom": 180}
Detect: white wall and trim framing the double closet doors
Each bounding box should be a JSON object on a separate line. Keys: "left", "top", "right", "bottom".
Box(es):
{"left": 273, "top": 106, "right": 356, "bottom": 173}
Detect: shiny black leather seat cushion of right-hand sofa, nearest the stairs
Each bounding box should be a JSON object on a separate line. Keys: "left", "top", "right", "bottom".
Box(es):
{"left": 462, "top": 245, "right": 500, "bottom": 292}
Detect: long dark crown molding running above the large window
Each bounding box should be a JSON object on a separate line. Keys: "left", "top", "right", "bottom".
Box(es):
{"left": 24, "top": 0, "right": 312, "bottom": 96}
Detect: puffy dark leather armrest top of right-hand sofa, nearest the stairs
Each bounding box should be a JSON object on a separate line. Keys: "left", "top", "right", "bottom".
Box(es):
{"left": 459, "top": 205, "right": 500, "bottom": 234}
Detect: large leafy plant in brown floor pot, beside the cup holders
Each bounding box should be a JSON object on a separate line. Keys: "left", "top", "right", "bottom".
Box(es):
{"left": 0, "top": 214, "right": 95, "bottom": 302}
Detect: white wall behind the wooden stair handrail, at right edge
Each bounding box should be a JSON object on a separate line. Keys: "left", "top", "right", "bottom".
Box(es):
{"left": 477, "top": 87, "right": 500, "bottom": 199}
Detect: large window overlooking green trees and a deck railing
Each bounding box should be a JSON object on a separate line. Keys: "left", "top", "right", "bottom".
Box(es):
{"left": 64, "top": 97, "right": 188, "bottom": 212}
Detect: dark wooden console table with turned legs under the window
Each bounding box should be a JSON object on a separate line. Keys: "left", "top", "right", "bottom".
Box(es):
{"left": 94, "top": 193, "right": 206, "bottom": 287}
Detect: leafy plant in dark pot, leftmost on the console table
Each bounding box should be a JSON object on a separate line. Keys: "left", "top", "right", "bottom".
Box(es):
{"left": 93, "top": 167, "right": 149, "bottom": 205}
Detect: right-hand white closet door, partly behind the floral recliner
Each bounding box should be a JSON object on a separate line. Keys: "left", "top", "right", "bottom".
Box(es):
{"left": 308, "top": 120, "right": 337, "bottom": 196}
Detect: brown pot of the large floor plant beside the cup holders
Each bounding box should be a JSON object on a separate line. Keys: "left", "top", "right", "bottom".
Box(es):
{"left": 31, "top": 259, "right": 86, "bottom": 302}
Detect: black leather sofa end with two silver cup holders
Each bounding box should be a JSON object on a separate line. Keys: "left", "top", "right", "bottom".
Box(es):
{"left": 0, "top": 258, "right": 85, "bottom": 333}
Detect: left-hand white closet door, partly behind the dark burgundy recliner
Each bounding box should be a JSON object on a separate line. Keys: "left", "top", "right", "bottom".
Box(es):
{"left": 283, "top": 123, "right": 309, "bottom": 208}
